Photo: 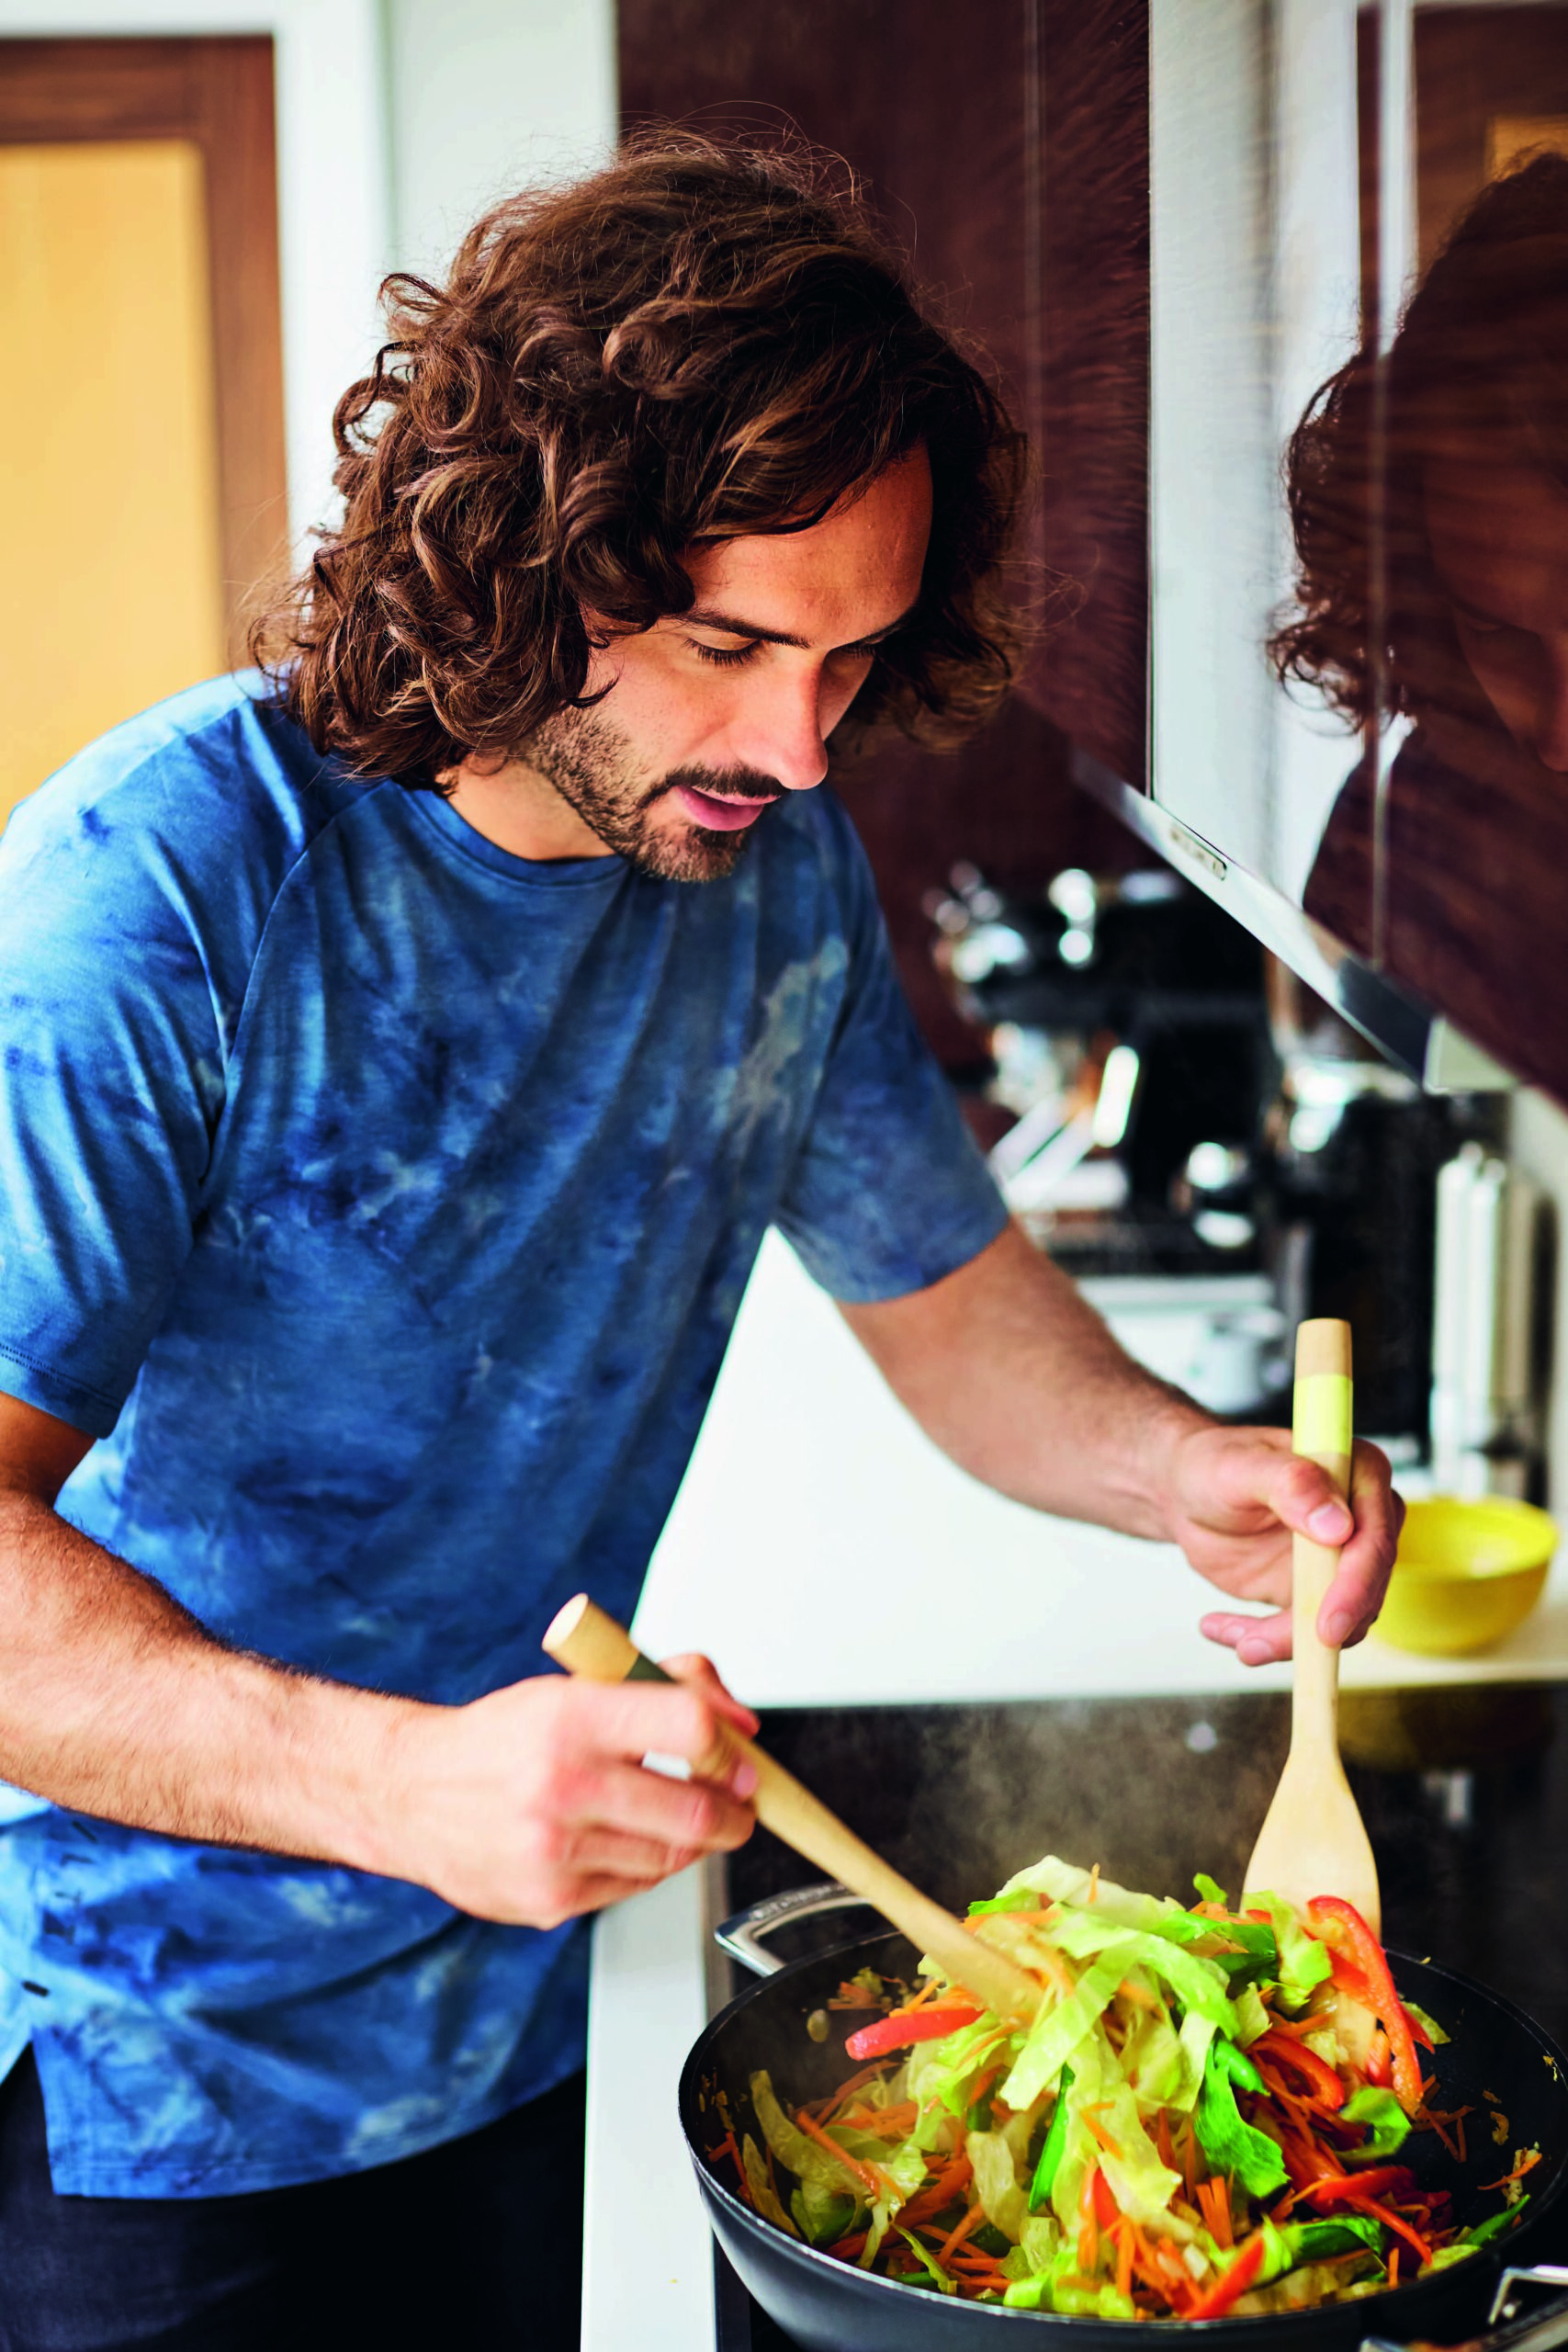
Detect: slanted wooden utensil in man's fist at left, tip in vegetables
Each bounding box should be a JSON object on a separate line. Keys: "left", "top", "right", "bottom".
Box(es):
{"left": 543, "top": 1592, "right": 1039, "bottom": 2023}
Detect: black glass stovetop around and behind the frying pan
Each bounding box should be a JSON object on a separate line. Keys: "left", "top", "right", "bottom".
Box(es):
{"left": 717, "top": 1683, "right": 1568, "bottom": 2352}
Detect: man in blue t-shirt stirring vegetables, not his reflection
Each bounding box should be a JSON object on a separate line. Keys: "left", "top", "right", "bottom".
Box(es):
{"left": 0, "top": 141, "right": 1392, "bottom": 2352}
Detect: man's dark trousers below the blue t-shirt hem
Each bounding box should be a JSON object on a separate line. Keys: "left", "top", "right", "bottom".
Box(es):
{"left": 0, "top": 2051, "right": 583, "bottom": 2352}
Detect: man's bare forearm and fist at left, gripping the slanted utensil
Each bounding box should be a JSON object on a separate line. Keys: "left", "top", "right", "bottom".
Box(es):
{"left": 0, "top": 1486, "right": 757, "bottom": 1927}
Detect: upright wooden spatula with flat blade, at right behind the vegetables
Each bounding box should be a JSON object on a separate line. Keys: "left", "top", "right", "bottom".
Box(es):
{"left": 1246, "top": 1319, "right": 1382, "bottom": 1936}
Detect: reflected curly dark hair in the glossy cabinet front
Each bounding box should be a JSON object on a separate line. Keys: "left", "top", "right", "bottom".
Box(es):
{"left": 1269, "top": 153, "right": 1568, "bottom": 727}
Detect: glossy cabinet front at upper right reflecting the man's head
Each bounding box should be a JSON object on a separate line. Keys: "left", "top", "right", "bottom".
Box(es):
{"left": 1149, "top": 0, "right": 1568, "bottom": 1096}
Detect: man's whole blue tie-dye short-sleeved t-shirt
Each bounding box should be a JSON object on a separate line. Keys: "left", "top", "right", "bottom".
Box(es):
{"left": 0, "top": 680, "right": 1001, "bottom": 2197}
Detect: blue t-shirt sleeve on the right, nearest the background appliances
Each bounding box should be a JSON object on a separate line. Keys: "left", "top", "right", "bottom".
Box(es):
{"left": 776, "top": 793, "right": 1006, "bottom": 1306}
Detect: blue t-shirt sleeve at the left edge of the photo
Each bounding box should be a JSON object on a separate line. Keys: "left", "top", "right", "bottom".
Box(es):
{"left": 0, "top": 719, "right": 247, "bottom": 1437}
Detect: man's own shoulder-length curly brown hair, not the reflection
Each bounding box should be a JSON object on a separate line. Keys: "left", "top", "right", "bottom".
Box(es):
{"left": 252, "top": 134, "right": 1025, "bottom": 788}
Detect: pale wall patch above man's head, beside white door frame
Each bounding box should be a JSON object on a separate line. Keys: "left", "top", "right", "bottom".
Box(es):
{"left": 383, "top": 0, "right": 616, "bottom": 273}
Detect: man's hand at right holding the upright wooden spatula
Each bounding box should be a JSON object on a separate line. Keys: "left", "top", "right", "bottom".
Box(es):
{"left": 1166, "top": 1425, "right": 1404, "bottom": 1665}
